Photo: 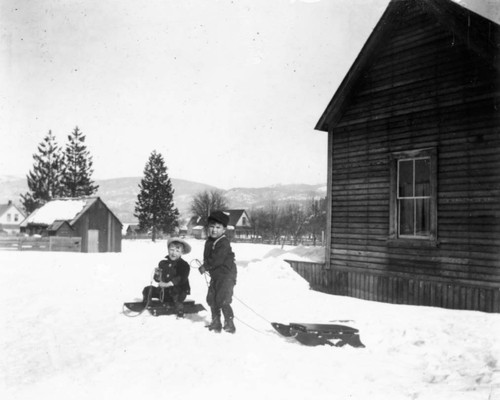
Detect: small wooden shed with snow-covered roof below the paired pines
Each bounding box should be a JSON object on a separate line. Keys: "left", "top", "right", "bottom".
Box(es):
{"left": 21, "top": 197, "right": 122, "bottom": 253}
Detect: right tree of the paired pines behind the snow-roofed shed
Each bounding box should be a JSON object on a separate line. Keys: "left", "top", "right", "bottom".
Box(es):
{"left": 63, "top": 127, "right": 99, "bottom": 197}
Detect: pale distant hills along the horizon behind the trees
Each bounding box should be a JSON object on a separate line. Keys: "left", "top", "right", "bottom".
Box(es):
{"left": 0, "top": 176, "right": 326, "bottom": 223}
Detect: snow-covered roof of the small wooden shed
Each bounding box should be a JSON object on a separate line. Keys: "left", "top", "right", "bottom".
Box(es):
{"left": 21, "top": 197, "right": 121, "bottom": 227}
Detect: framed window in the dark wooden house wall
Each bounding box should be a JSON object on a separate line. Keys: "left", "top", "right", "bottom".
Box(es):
{"left": 389, "top": 149, "right": 437, "bottom": 241}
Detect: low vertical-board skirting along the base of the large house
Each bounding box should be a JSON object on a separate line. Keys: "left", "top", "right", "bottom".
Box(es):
{"left": 285, "top": 260, "right": 500, "bottom": 313}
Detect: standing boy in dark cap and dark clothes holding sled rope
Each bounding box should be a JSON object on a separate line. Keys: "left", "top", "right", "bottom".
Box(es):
{"left": 199, "top": 211, "right": 236, "bottom": 333}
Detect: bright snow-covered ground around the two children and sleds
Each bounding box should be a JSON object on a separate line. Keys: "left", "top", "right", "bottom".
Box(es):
{"left": 0, "top": 240, "right": 500, "bottom": 400}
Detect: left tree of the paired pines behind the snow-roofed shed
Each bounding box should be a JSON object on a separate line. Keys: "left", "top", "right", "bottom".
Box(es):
{"left": 21, "top": 131, "right": 64, "bottom": 214}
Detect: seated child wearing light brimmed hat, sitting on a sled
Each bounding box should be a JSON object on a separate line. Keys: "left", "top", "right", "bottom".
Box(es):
{"left": 142, "top": 237, "right": 191, "bottom": 318}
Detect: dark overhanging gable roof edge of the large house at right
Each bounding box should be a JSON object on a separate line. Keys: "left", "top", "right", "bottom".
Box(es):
{"left": 315, "top": 0, "right": 500, "bottom": 132}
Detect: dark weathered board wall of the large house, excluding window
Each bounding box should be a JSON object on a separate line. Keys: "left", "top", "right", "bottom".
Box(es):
{"left": 324, "top": 2, "right": 500, "bottom": 311}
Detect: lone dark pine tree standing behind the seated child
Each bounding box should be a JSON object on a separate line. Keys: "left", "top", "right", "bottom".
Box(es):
{"left": 134, "top": 151, "right": 179, "bottom": 242}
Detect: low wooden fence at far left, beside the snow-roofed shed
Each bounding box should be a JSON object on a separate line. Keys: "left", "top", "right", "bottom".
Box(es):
{"left": 0, "top": 236, "right": 82, "bottom": 252}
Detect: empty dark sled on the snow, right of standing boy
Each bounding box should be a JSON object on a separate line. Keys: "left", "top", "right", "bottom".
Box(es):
{"left": 271, "top": 322, "right": 365, "bottom": 347}
